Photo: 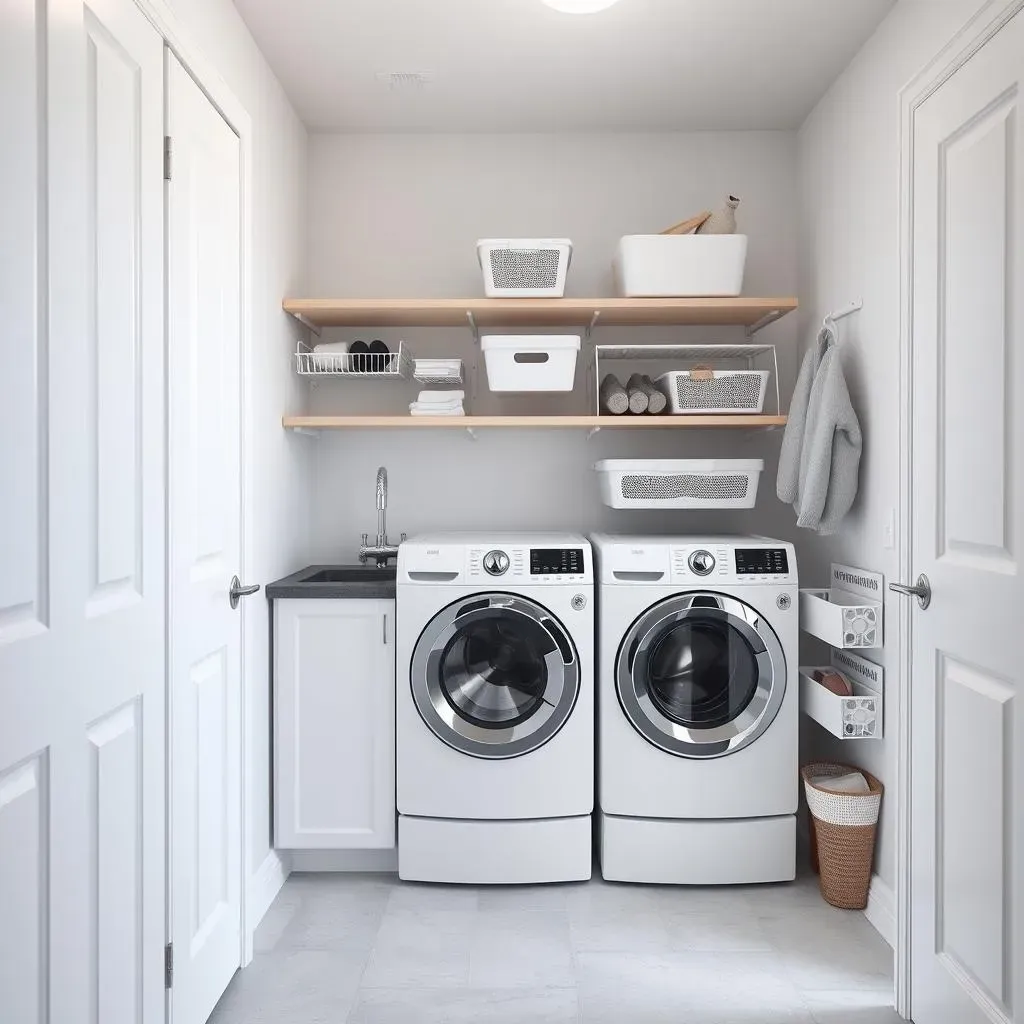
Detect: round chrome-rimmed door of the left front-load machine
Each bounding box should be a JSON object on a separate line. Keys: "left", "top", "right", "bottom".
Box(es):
{"left": 411, "top": 594, "right": 580, "bottom": 758}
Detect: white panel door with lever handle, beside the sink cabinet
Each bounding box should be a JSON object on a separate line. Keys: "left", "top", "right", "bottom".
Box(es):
{"left": 167, "top": 54, "right": 247, "bottom": 1024}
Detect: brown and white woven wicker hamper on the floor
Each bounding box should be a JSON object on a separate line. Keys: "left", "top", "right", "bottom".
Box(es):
{"left": 801, "top": 762, "right": 885, "bottom": 910}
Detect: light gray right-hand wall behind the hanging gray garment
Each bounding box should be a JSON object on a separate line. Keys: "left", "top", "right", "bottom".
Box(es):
{"left": 800, "top": 0, "right": 981, "bottom": 886}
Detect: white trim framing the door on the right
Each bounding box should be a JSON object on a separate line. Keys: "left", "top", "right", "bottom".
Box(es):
{"left": 897, "top": 0, "right": 1024, "bottom": 1020}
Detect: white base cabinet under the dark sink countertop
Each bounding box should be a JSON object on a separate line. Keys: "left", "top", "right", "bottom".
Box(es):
{"left": 273, "top": 598, "right": 396, "bottom": 850}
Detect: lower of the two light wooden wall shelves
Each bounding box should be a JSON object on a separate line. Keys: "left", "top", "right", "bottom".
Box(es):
{"left": 282, "top": 416, "right": 786, "bottom": 430}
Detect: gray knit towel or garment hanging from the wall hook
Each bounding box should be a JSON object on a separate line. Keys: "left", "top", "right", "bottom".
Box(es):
{"left": 776, "top": 328, "right": 863, "bottom": 534}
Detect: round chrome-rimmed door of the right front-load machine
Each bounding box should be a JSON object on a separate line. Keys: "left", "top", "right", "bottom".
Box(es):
{"left": 616, "top": 593, "right": 786, "bottom": 758}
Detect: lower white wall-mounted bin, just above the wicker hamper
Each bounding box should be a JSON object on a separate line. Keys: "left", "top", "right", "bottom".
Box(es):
{"left": 800, "top": 650, "right": 885, "bottom": 739}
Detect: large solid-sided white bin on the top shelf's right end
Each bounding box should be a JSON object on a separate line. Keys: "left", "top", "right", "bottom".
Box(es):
{"left": 614, "top": 234, "right": 746, "bottom": 298}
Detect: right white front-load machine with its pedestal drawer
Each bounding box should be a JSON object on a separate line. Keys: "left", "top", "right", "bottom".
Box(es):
{"left": 592, "top": 536, "right": 799, "bottom": 885}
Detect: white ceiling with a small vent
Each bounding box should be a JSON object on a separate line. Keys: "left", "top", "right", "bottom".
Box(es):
{"left": 234, "top": 0, "right": 895, "bottom": 132}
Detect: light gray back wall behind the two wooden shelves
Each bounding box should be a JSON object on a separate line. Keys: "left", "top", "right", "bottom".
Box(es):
{"left": 308, "top": 132, "right": 799, "bottom": 560}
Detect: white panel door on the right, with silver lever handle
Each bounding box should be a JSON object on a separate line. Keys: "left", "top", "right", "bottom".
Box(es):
{"left": 907, "top": 14, "right": 1024, "bottom": 1024}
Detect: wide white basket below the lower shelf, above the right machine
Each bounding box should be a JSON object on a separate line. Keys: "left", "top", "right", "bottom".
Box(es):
{"left": 594, "top": 459, "right": 765, "bottom": 509}
